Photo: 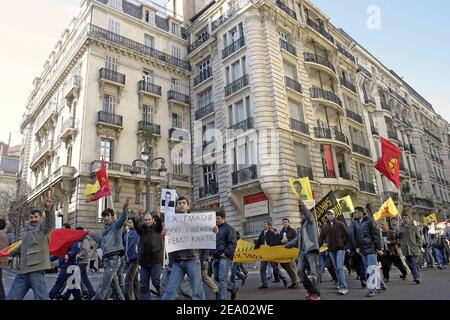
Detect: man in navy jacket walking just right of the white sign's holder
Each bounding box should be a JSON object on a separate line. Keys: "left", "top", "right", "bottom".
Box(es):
{"left": 212, "top": 211, "right": 238, "bottom": 300}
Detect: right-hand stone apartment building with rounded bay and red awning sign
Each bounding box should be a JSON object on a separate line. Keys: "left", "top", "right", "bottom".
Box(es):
{"left": 187, "top": 0, "right": 449, "bottom": 236}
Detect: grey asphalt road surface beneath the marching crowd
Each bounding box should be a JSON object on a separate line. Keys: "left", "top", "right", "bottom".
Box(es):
{"left": 3, "top": 268, "right": 450, "bottom": 300}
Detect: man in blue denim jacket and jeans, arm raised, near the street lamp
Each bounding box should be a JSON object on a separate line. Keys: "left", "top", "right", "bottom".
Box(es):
{"left": 89, "top": 197, "right": 131, "bottom": 300}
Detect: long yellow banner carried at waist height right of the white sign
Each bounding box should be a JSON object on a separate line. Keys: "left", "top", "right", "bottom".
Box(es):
{"left": 233, "top": 240, "right": 298, "bottom": 263}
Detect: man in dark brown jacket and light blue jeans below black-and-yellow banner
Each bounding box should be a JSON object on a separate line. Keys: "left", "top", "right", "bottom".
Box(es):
{"left": 319, "top": 209, "right": 350, "bottom": 295}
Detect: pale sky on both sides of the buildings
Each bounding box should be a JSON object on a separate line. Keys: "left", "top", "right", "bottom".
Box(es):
{"left": 0, "top": 0, "right": 450, "bottom": 144}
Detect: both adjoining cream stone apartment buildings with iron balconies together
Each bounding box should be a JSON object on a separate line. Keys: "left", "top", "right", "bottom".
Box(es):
{"left": 21, "top": 0, "right": 450, "bottom": 237}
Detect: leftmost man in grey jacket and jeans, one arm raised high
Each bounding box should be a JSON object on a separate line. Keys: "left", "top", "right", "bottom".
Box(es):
{"left": 7, "top": 192, "right": 55, "bottom": 300}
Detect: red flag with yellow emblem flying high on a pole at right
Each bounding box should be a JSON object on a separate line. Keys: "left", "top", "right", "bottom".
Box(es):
{"left": 375, "top": 137, "right": 402, "bottom": 189}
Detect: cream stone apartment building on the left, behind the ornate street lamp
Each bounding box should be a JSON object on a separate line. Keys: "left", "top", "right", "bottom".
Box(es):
{"left": 21, "top": 0, "right": 191, "bottom": 230}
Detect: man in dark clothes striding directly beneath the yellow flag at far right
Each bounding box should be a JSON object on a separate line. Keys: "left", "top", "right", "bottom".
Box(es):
{"left": 380, "top": 222, "right": 408, "bottom": 283}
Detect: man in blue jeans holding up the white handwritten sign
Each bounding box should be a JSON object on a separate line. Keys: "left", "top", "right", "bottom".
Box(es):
{"left": 162, "top": 197, "right": 211, "bottom": 300}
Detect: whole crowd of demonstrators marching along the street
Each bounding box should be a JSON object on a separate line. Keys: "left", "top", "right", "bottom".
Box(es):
{"left": 0, "top": 186, "right": 450, "bottom": 301}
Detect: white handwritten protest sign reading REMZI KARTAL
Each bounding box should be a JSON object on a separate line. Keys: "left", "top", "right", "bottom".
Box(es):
{"left": 164, "top": 212, "right": 216, "bottom": 253}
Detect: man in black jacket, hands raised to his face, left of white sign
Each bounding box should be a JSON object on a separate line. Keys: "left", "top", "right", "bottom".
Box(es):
{"left": 133, "top": 208, "right": 164, "bottom": 300}
